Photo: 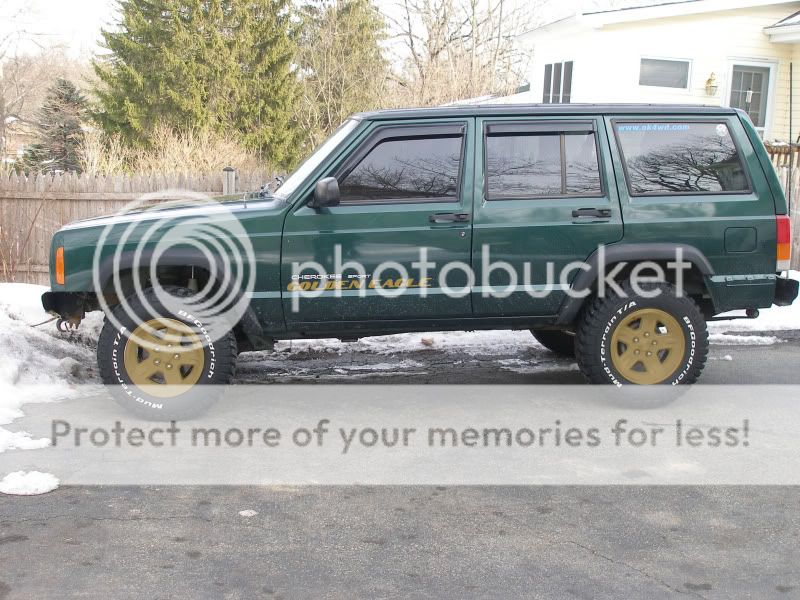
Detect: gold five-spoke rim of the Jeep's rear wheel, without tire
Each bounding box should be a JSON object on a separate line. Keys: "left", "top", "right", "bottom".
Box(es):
{"left": 610, "top": 308, "right": 686, "bottom": 385}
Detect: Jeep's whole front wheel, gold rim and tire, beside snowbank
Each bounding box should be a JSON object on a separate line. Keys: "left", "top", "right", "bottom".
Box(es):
{"left": 97, "top": 288, "right": 237, "bottom": 421}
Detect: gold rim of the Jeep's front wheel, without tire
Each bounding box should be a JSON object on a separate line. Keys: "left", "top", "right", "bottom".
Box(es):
{"left": 123, "top": 318, "right": 205, "bottom": 398}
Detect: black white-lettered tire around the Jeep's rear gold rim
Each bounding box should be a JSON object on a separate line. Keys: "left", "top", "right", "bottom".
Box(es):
{"left": 575, "top": 282, "right": 708, "bottom": 386}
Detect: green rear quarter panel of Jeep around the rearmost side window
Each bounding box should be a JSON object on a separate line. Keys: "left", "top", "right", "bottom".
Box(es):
{"left": 606, "top": 110, "right": 776, "bottom": 313}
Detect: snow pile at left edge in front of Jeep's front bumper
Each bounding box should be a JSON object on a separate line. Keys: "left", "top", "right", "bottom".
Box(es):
{"left": 0, "top": 283, "right": 102, "bottom": 452}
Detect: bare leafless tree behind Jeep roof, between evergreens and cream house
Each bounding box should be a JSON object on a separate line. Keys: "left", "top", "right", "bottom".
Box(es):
{"left": 391, "top": 0, "right": 544, "bottom": 106}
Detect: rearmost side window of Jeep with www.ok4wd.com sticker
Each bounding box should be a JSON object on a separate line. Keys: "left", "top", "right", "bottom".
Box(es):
{"left": 614, "top": 121, "right": 750, "bottom": 196}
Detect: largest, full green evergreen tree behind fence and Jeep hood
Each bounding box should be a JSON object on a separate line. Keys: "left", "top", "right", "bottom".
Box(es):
{"left": 95, "top": 0, "right": 300, "bottom": 166}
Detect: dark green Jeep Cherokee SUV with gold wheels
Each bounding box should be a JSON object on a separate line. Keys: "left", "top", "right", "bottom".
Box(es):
{"left": 42, "top": 105, "right": 798, "bottom": 418}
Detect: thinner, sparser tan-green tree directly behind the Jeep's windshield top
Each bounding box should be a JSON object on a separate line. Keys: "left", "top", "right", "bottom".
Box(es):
{"left": 298, "top": 0, "right": 389, "bottom": 146}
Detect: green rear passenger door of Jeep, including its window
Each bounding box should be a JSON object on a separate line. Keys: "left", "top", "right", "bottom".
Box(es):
{"left": 472, "top": 117, "right": 622, "bottom": 316}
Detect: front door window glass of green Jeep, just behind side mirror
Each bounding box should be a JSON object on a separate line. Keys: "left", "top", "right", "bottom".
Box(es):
{"left": 339, "top": 135, "right": 463, "bottom": 204}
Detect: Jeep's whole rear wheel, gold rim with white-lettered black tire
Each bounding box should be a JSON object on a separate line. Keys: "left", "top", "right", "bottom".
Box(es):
{"left": 575, "top": 283, "right": 708, "bottom": 385}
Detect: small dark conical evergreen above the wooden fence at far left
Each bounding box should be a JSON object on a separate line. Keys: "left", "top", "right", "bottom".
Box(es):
{"left": 22, "top": 79, "right": 86, "bottom": 172}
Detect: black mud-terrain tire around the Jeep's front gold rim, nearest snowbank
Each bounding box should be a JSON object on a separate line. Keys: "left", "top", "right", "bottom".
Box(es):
{"left": 97, "top": 287, "right": 237, "bottom": 421}
